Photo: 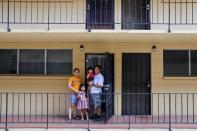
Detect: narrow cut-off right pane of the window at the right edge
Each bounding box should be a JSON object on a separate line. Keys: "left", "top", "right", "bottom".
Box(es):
{"left": 191, "top": 50, "right": 197, "bottom": 76}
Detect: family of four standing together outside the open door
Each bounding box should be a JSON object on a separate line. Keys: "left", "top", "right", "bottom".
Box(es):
{"left": 68, "top": 65, "right": 104, "bottom": 122}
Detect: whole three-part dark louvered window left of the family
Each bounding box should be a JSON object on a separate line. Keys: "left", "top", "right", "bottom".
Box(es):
{"left": 0, "top": 49, "right": 72, "bottom": 75}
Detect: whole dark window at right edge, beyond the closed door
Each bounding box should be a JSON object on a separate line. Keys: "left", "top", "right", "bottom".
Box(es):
{"left": 163, "top": 50, "right": 197, "bottom": 77}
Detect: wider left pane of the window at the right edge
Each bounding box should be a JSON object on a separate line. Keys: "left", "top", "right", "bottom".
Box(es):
{"left": 163, "top": 50, "right": 189, "bottom": 76}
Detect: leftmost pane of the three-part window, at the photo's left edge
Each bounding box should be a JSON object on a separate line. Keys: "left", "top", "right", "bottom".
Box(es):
{"left": 0, "top": 49, "right": 17, "bottom": 74}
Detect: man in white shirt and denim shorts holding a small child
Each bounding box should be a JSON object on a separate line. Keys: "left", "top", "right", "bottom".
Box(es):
{"left": 89, "top": 65, "right": 104, "bottom": 121}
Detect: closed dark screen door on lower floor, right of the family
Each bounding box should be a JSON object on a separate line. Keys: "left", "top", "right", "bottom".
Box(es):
{"left": 122, "top": 53, "right": 151, "bottom": 115}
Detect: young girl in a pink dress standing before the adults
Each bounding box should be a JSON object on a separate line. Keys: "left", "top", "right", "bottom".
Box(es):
{"left": 77, "top": 84, "right": 89, "bottom": 120}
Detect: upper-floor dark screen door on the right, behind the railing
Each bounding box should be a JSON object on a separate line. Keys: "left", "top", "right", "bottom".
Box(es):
{"left": 122, "top": 0, "right": 150, "bottom": 30}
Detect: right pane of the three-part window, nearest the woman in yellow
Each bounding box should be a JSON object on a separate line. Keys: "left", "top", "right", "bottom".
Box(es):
{"left": 47, "top": 50, "right": 72, "bottom": 75}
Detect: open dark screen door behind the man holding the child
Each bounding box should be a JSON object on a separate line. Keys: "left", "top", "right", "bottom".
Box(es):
{"left": 86, "top": 53, "right": 114, "bottom": 122}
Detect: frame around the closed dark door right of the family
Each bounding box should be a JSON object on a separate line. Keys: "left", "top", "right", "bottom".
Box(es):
{"left": 121, "top": 52, "right": 153, "bottom": 116}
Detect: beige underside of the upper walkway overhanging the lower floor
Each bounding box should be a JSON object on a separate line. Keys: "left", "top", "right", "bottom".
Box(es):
{"left": 0, "top": 31, "right": 197, "bottom": 43}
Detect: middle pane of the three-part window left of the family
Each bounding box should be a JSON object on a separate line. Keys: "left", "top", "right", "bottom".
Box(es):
{"left": 19, "top": 50, "right": 45, "bottom": 74}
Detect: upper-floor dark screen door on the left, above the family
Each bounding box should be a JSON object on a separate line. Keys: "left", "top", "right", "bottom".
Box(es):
{"left": 87, "top": 0, "right": 114, "bottom": 29}
